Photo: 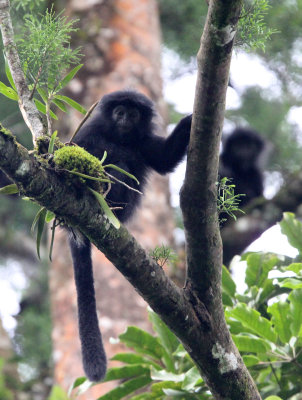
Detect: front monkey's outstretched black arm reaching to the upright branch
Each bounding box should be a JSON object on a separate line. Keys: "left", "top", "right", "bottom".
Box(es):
{"left": 141, "top": 115, "right": 192, "bottom": 174}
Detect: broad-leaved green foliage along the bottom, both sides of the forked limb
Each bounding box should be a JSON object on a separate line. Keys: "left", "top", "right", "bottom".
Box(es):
{"left": 54, "top": 213, "right": 302, "bottom": 400}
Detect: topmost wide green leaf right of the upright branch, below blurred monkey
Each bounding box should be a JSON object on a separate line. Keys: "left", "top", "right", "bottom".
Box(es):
{"left": 245, "top": 253, "right": 280, "bottom": 287}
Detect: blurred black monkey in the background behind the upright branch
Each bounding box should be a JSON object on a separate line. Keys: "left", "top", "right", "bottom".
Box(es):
{"left": 219, "top": 128, "right": 265, "bottom": 206}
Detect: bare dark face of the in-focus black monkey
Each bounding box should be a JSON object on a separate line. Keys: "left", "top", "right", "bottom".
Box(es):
{"left": 112, "top": 105, "right": 141, "bottom": 139}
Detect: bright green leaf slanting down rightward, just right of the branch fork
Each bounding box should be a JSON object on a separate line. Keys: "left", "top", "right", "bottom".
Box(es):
{"left": 226, "top": 303, "right": 277, "bottom": 343}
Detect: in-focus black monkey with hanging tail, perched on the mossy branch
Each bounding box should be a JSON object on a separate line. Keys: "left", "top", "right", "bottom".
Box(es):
{"left": 69, "top": 91, "right": 192, "bottom": 381}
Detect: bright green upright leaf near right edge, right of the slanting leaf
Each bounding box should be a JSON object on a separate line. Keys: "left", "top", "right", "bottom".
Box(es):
{"left": 267, "top": 301, "right": 292, "bottom": 343}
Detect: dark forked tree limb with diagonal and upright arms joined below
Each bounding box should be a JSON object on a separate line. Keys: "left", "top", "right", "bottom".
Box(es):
{"left": 0, "top": 0, "right": 260, "bottom": 400}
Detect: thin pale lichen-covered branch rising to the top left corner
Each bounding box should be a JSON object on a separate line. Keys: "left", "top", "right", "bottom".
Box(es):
{"left": 0, "top": 0, "right": 45, "bottom": 140}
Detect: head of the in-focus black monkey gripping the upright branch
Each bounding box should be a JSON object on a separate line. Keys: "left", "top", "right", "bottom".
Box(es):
{"left": 98, "top": 91, "right": 155, "bottom": 143}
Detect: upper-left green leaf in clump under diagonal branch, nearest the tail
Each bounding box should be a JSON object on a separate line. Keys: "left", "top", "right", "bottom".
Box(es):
{"left": 119, "top": 326, "right": 164, "bottom": 360}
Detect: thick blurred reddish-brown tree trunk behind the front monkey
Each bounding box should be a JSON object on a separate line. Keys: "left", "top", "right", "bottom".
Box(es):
{"left": 50, "top": 0, "right": 174, "bottom": 399}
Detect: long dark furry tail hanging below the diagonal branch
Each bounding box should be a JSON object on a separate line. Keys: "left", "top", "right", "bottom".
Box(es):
{"left": 69, "top": 236, "right": 107, "bottom": 382}
